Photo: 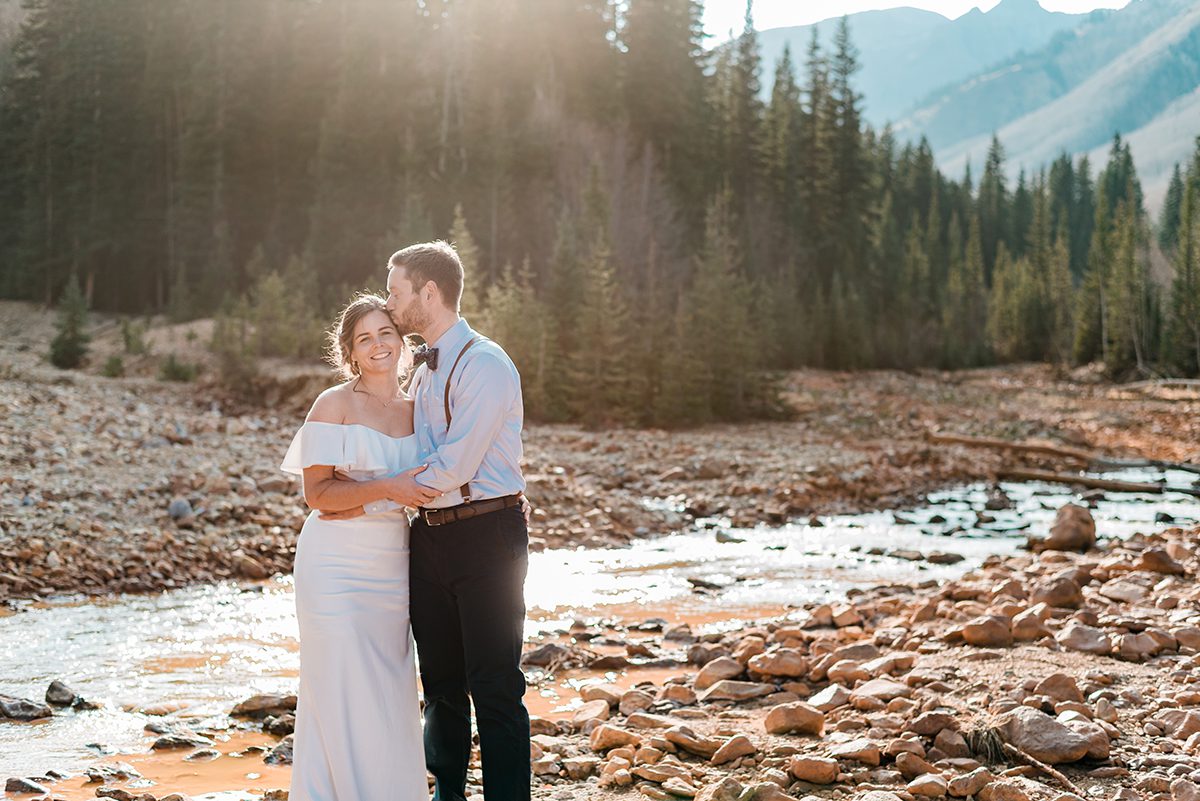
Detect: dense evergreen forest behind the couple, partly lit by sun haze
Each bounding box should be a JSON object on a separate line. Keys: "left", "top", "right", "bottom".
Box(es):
{"left": 0, "top": 0, "right": 1200, "bottom": 424}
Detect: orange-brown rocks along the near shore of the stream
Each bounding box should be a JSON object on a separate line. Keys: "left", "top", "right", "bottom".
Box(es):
{"left": 0, "top": 506, "right": 1200, "bottom": 801}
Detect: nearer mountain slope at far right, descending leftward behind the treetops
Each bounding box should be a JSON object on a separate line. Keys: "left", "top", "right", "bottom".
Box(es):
{"left": 895, "top": 0, "right": 1200, "bottom": 209}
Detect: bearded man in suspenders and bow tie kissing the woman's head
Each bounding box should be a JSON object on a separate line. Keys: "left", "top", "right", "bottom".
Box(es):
{"left": 326, "top": 241, "right": 529, "bottom": 801}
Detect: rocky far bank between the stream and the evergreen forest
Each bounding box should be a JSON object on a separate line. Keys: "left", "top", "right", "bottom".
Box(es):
{"left": 0, "top": 298, "right": 1200, "bottom": 603}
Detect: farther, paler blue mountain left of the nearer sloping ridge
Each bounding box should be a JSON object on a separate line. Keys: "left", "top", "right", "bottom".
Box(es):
{"left": 760, "top": 0, "right": 1085, "bottom": 127}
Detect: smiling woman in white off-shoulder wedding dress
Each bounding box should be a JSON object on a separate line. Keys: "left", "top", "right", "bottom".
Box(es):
{"left": 282, "top": 295, "right": 436, "bottom": 801}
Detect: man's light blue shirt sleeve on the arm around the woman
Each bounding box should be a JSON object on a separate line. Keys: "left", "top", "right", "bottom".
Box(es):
{"left": 414, "top": 351, "right": 521, "bottom": 493}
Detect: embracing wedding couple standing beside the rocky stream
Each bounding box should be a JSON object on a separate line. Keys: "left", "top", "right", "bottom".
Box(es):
{"left": 282, "top": 242, "right": 529, "bottom": 801}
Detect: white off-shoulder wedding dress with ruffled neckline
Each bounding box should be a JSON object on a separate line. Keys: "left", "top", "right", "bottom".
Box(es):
{"left": 281, "top": 422, "right": 428, "bottom": 801}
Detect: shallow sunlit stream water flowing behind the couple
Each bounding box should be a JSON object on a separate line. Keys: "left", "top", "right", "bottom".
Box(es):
{"left": 0, "top": 470, "right": 1200, "bottom": 799}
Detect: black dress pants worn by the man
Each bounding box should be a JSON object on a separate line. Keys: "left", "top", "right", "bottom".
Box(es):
{"left": 409, "top": 508, "right": 530, "bottom": 801}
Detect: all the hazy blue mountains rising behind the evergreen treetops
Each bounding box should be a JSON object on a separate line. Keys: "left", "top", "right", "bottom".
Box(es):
{"left": 760, "top": 0, "right": 1200, "bottom": 211}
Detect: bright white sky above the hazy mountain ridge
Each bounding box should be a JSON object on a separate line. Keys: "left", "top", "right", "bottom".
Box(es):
{"left": 704, "top": 0, "right": 1129, "bottom": 40}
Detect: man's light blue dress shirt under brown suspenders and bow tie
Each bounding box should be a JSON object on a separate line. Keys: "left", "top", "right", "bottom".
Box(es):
{"left": 412, "top": 320, "right": 526, "bottom": 508}
